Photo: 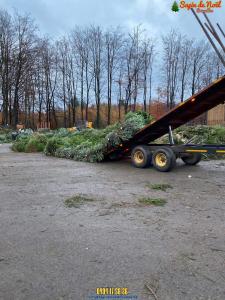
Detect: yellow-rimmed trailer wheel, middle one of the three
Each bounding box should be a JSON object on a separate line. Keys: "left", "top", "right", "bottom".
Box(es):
{"left": 152, "top": 148, "right": 176, "bottom": 172}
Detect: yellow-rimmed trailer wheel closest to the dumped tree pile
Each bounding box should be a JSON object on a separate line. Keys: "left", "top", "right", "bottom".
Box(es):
{"left": 131, "top": 146, "right": 152, "bottom": 168}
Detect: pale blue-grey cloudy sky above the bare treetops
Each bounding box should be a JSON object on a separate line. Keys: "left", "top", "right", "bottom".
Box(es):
{"left": 0, "top": 0, "right": 225, "bottom": 39}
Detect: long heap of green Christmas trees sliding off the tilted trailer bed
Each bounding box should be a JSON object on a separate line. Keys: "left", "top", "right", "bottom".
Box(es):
{"left": 13, "top": 112, "right": 152, "bottom": 162}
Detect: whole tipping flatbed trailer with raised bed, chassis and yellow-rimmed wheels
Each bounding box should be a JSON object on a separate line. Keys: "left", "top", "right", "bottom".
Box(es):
{"left": 106, "top": 76, "right": 225, "bottom": 172}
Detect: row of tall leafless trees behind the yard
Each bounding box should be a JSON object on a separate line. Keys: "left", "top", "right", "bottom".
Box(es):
{"left": 0, "top": 10, "right": 224, "bottom": 127}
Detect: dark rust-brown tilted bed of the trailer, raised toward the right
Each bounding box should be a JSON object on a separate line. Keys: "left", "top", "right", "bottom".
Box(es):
{"left": 108, "top": 76, "right": 225, "bottom": 155}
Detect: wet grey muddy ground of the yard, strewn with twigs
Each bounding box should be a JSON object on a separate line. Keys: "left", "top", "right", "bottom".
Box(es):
{"left": 0, "top": 145, "right": 225, "bottom": 300}
